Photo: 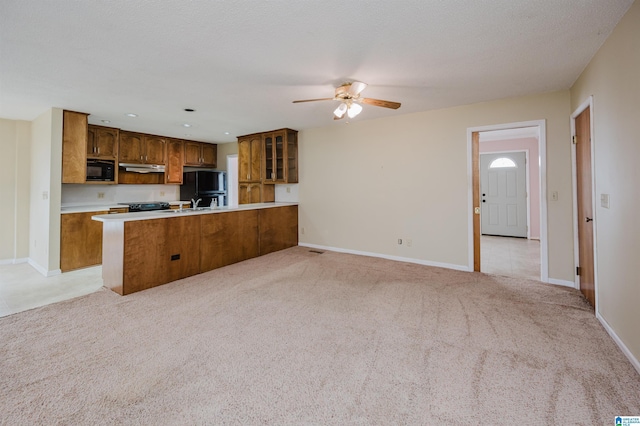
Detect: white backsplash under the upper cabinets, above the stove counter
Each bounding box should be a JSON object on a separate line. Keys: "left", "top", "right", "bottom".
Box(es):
{"left": 62, "top": 184, "right": 180, "bottom": 206}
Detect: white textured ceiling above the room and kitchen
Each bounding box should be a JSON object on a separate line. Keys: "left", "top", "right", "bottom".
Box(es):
{"left": 0, "top": 0, "right": 633, "bottom": 142}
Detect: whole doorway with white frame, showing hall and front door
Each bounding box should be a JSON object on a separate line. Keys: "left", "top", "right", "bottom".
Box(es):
{"left": 467, "top": 120, "right": 549, "bottom": 282}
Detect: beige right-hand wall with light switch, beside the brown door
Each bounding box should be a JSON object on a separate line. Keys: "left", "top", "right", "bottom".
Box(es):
{"left": 571, "top": 2, "right": 640, "bottom": 359}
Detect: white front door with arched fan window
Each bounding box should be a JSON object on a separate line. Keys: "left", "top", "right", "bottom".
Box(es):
{"left": 480, "top": 152, "right": 527, "bottom": 238}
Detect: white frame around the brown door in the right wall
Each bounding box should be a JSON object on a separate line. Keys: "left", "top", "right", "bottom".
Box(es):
{"left": 571, "top": 95, "right": 598, "bottom": 300}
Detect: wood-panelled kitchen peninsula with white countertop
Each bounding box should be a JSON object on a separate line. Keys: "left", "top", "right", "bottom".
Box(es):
{"left": 92, "top": 203, "right": 298, "bottom": 295}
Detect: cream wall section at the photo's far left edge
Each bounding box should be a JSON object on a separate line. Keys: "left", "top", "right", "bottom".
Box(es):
{"left": 0, "top": 119, "right": 30, "bottom": 263}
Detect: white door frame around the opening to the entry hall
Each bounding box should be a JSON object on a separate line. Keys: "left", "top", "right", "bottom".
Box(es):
{"left": 467, "top": 120, "right": 549, "bottom": 283}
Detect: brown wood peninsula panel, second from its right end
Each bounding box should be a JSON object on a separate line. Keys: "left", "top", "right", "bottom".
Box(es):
{"left": 200, "top": 210, "right": 258, "bottom": 272}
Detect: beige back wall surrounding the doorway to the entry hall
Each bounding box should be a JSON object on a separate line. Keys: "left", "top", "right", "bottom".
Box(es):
{"left": 299, "top": 91, "right": 574, "bottom": 282}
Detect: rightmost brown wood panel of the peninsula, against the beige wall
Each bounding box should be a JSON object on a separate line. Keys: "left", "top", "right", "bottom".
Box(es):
{"left": 258, "top": 206, "right": 298, "bottom": 256}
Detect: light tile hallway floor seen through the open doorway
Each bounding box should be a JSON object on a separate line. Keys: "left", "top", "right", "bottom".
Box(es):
{"left": 480, "top": 235, "right": 540, "bottom": 280}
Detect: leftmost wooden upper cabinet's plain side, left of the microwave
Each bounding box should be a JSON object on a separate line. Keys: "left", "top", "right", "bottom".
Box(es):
{"left": 62, "top": 111, "right": 89, "bottom": 183}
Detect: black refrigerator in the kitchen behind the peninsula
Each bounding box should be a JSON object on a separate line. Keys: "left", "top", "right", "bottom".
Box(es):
{"left": 180, "top": 170, "right": 228, "bottom": 207}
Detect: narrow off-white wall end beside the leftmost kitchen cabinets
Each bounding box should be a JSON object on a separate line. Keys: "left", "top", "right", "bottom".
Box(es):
{"left": 29, "top": 108, "right": 62, "bottom": 275}
